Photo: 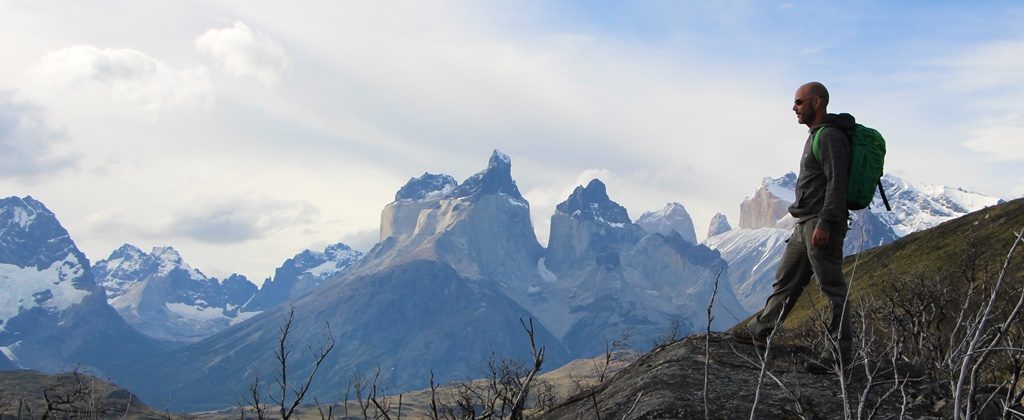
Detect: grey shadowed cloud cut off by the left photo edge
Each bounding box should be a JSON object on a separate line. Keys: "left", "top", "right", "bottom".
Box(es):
{"left": 0, "top": 93, "right": 81, "bottom": 180}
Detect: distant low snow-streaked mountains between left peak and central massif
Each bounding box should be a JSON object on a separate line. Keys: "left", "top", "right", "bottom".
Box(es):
{"left": 93, "top": 240, "right": 362, "bottom": 345}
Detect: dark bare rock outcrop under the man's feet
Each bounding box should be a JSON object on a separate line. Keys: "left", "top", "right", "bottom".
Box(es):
{"left": 540, "top": 334, "right": 943, "bottom": 420}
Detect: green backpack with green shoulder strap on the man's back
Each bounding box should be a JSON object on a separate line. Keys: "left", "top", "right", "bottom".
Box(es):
{"left": 811, "top": 124, "right": 892, "bottom": 211}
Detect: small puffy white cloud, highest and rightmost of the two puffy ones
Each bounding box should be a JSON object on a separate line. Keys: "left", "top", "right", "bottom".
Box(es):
{"left": 196, "top": 22, "right": 292, "bottom": 84}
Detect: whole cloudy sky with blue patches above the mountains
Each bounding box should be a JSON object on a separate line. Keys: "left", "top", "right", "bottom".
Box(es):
{"left": 0, "top": 0, "right": 1024, "bottom": 282}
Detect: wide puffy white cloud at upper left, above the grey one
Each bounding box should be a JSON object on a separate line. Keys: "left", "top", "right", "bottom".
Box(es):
{"left": 25, "top": 45, "right": 211, "bottom": 120}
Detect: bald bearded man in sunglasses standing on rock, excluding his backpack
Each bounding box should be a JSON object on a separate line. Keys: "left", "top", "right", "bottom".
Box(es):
{"left": 734, "top": 82, "right": 854, "bottom": 373}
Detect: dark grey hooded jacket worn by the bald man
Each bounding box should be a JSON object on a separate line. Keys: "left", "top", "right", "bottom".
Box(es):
{"left": 790, "top": 114, "right": 855, "bottom": 232}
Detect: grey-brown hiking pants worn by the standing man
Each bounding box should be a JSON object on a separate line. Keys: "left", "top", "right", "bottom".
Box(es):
{"left": 746, "top": 218, "right": 853, "bottom": 359}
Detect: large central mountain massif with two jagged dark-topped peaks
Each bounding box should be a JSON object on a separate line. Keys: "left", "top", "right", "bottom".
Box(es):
{"left": 103, "top": 151, "right": 740, "bottom": 409}
